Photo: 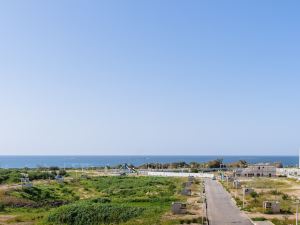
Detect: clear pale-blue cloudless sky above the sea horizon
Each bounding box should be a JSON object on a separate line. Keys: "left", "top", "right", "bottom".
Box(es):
{"left": 0, "top": 0, "right": 300, "bottom": 155}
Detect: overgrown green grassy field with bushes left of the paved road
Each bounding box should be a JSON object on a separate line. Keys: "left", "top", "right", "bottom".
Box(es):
{"left": 0, "top": 171, "right": 202, "bottom": 225}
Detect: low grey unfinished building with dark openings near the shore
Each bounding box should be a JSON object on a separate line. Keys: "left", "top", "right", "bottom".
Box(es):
{"left": 235, "top": 164, "right": 276, "bottom": 177}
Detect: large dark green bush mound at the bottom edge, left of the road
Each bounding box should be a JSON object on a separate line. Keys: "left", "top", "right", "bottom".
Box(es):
{"left": 48, "top": 202, "right": 144, "bottom": 225}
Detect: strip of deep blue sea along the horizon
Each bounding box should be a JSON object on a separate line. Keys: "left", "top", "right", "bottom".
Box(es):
{"left": 0, "top": 155, "right": 298, "bottom": 168}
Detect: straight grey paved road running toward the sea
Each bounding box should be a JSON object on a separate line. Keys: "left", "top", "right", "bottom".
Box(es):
{"left": 205, "top": 179, "right": 252, "bottom": 225}
